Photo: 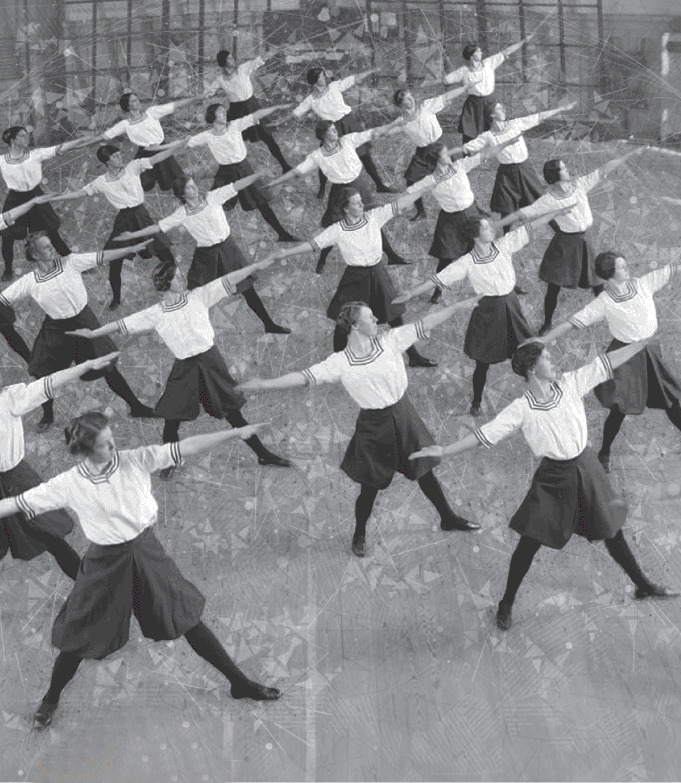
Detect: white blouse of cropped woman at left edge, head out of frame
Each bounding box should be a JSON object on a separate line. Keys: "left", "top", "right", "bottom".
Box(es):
{"left": 0, "top": 375, "right": 57, "bottom": 473}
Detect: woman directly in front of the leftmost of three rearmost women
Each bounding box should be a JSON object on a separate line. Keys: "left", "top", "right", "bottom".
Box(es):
{"left": 187, "top": 103, "right": 300, "bottom": 242}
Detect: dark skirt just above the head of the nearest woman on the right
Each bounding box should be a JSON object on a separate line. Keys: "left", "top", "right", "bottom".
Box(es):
{"left": 463, "top": 291, "right": 534, "bottom": 364}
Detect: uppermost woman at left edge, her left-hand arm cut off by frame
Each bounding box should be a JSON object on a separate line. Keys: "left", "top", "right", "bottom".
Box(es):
{"left": 0, "top": 125, "right": 96, "bottom": 282}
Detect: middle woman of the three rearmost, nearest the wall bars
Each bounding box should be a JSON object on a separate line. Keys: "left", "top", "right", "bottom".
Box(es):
{"left": 282, "top": 68, "right": 396, "bottom": 199}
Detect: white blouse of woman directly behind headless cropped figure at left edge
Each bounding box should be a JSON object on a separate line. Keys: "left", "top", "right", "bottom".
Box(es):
{"left": 0, "top": 253, "right": 104, "bottom": 320}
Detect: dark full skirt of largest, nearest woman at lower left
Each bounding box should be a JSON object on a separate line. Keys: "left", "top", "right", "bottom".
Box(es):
{"left": 52, "top": 528, "right": 206, "bottom": 660}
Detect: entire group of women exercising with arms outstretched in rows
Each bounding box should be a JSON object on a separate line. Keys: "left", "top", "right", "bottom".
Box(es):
{"left": 0, "top": 36, "right": 681, "bottom": 728}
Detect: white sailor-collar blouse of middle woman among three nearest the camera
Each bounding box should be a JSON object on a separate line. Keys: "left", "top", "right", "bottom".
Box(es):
{"left": 303, "top": 321, "right": 430, "bottom": 410}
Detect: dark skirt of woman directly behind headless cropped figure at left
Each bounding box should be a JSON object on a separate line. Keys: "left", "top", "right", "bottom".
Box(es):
{"left": 28, "top": 305, "right": 118, "bottom": 381}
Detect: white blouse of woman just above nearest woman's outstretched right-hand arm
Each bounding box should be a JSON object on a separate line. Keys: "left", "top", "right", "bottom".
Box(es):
{"left": 116, "top": 277, "right": 236, "bottom": 359}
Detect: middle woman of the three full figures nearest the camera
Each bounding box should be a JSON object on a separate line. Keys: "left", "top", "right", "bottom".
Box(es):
{"left": 237, "top": 297, "right": 480, "bottom": 557}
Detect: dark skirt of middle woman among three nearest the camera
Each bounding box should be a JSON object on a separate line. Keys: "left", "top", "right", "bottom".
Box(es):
{"left": 341, "top": 393, "right": 440, "bottom": 489}
